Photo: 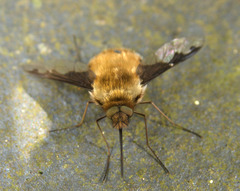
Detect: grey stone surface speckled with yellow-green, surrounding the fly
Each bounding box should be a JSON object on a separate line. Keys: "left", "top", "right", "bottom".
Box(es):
{"left": 0, "top": 0, "right": 240, "bottom": 190}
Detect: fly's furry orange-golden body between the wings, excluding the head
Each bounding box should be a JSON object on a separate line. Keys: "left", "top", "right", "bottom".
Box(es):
{"left": 89, "top": 49, "right": 144, "bottom": 111}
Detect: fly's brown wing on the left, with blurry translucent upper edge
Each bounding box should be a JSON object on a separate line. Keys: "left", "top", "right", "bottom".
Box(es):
{"left": 23, "top": 61, "right": 95, "bottom": 90}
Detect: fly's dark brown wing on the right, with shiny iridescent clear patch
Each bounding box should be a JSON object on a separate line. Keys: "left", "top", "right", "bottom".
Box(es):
{"left": 137, "top": 38, "right": 203, "bottom": 85}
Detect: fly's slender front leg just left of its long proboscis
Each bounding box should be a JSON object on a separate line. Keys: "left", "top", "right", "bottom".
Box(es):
{"left": 96, "top": 115, "right": 111, "bottom": 182}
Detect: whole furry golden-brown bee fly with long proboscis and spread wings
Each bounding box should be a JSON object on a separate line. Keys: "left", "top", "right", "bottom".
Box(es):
{"left": 25, "top": 38, "right": 203, "bottom": 181}
